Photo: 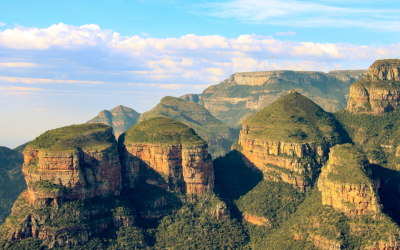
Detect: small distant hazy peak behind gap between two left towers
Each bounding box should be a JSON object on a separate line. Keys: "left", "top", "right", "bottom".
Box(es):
{"left": 87, "top": 105, "right": 140, "bottom": 140}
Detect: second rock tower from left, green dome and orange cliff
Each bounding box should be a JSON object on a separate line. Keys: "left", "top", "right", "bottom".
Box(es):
{"left": 119, "top": 117, "right": 214, "bottom": 194}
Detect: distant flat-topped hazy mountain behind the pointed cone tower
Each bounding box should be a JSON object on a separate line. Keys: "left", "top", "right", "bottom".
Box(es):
{"left": 181, "top": 70, "right": 367, "bottom": 128}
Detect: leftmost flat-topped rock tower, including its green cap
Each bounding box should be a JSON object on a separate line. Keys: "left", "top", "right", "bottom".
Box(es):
{"left": 22, "top": 124, "right": 122, "bottom": 207}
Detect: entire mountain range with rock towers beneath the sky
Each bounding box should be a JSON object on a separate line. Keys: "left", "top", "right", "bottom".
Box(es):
{"left": 0, "top": 59, "right": 400, "bottom": 250}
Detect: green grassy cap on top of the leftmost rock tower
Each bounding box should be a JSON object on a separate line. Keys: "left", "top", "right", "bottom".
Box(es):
{"left": 27, "top": 123, "right": 115, "bottom": 152}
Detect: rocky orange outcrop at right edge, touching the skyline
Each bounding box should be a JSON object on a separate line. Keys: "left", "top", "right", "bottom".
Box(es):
{"left": 347, "top": 59, "right": 400, "bottom": 115}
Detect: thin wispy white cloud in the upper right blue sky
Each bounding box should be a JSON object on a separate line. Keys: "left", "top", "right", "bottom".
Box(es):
{"left": 202, "top": 0, "right": 400, "bottom": 32}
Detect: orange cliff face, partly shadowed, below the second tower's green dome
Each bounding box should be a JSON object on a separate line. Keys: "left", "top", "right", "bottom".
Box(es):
{"left": 122, "top": 143, "right": 214, "bottom": 194}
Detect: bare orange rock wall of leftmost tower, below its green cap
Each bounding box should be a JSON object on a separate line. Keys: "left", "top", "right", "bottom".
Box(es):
{"left": 22, "top": 126, "right": 122, "bottom": 207}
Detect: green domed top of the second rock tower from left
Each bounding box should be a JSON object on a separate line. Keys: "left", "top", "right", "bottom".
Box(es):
{"left": 120, "top": 117, "right": 205, "bottom": 145}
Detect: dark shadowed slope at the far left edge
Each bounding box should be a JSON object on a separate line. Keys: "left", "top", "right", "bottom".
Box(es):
{"left": 0, "top": 147, "right": 26, "bottom": 223}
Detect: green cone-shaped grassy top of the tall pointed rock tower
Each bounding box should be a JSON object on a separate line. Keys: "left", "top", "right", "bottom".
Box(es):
{"left": 243, "top": 91, "right": 342, "bottom": 145}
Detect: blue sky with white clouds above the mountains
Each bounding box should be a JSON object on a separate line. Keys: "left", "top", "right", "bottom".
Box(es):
{"left": 0, "top": 0, "right": 400, "bottom": 148}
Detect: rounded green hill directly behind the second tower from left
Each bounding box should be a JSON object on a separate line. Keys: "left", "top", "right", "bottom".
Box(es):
{"left": 139, "top": 96, "right": 234, "bottom": 158}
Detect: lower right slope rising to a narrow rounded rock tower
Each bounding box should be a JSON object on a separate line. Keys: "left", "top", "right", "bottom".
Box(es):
{"left": 257, "top": 144, "right": 400, "bottom": 250}
